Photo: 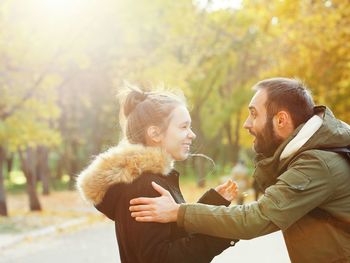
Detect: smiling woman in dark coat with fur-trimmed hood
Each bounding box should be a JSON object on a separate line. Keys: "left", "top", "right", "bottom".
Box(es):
{"left": 77, "top": 89, "right": 236, "bottom": 263}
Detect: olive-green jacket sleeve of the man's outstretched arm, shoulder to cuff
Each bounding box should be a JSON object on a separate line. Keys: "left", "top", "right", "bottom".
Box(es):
{"left": 177, "top": 151, "right": 334, "bottom": 239}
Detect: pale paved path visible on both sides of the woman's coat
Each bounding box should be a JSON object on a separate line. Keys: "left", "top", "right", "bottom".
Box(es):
{"left": 0, "top": 222, "right": 290, "bottom": 263}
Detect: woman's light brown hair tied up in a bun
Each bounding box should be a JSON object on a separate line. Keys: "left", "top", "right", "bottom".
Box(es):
{"left": 119, "top": 85, "right": 186, "bottom": 145}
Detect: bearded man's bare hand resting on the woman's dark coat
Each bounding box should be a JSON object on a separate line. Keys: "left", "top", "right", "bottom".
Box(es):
{"left": 129, "top": 182, "right": 180, "bottom": 223}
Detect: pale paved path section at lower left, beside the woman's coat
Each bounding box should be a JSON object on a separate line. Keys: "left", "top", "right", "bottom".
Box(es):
{"left": 0, "top": 222, "right": 120, "bottom": 263}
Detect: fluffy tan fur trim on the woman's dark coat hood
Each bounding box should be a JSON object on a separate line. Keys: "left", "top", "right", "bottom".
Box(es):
{"left": 77, "top": 144, "right": 173, "bottom": 205}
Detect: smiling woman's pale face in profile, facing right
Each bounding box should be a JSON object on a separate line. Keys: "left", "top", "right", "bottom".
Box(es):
{"left": 160, "top": 105, "right": 196, "bottom": 161}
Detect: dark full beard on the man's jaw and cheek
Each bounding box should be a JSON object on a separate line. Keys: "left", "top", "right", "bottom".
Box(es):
{"left": 254, "top": 116, "right": 283, "bottom": 157}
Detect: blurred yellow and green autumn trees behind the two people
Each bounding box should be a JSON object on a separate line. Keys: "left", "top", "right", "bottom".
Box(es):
{"left": 0, "top": 0, "right": 350, "bottom": 215}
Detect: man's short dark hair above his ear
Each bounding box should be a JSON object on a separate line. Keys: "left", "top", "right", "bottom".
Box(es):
{"left": 253, "top": 78, "right": 315, "bottom": 128}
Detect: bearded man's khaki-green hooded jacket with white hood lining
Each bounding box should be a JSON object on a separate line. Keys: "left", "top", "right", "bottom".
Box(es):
{"left": 177, "top": 106, "right": 350, "bottom": 263}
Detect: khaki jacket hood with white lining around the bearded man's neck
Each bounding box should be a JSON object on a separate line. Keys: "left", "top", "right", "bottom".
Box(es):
{"left": 254, "top": 106, "right": 350, "bottom": 189}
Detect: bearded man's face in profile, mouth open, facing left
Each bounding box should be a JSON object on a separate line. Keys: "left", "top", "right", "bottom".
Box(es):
{"left": 243, "top": 89, "right": 283, "bottom": 157}
